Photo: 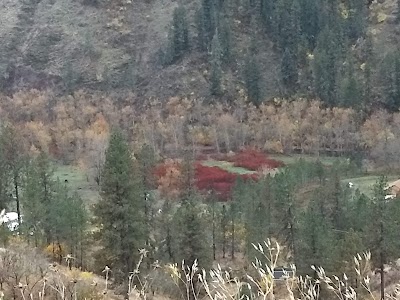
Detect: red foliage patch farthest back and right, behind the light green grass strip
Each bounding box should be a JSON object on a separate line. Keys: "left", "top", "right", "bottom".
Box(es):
{"left": 230, "top": 149, "right": 284, "bottom": 171}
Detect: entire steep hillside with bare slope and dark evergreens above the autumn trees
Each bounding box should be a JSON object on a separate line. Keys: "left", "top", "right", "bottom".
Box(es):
{"left": 0, "top": 0, "right": 400, "bottom": 112}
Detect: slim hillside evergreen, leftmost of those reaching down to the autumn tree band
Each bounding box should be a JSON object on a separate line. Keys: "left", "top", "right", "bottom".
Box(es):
{"left": 210, "top": 31, "right": 222, "bottom": 96}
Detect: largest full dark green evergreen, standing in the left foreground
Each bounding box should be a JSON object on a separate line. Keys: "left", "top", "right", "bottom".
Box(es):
{"left": 94, "top": 131, "right": 148, "bottom": 281}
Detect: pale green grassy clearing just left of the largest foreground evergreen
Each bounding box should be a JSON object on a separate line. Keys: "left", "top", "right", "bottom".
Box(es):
{"left": 54, "top": 165, "right": 99, "bottom": 205}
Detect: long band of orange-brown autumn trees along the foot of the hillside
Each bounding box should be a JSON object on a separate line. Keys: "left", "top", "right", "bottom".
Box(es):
{"left": 0, "top": 91, "right": 400, "bottom": 169}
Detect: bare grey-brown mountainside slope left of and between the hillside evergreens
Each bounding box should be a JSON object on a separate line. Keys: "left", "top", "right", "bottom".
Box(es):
{"left": 0, "top": 0, "right": 279, "bottom": 98}
